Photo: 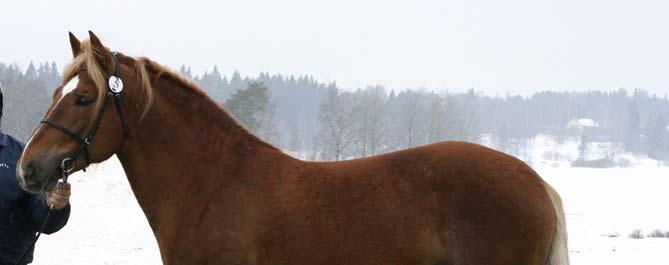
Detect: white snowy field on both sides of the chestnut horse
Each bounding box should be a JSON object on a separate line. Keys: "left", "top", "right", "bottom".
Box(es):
{"left": 34, "top": 155, "right": 669, "bottom": 265}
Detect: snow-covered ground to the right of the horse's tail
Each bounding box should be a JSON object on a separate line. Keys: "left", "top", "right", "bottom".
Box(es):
{"left": 535, "top": 167, "right": 669, "bottom": 265}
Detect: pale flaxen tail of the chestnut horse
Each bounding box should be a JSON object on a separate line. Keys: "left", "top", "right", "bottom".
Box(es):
{"left": 544, "top": 183, "right": 569, "bottom": 265}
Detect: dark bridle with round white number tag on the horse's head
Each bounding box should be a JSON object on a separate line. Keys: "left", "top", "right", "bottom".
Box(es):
{"left": 40, "top": 52, "right": 127, "bottom": 176}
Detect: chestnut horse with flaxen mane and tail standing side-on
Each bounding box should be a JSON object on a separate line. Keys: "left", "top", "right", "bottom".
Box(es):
{"left": 17, "top": 32, "right": 568, "bottom": 265}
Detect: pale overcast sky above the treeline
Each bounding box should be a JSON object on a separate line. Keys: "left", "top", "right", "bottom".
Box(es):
{"left": 0, "top": 0, "right": 669, "bottom": 94}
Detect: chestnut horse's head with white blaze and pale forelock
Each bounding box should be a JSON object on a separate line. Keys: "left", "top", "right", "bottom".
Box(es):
{"left": 17, "top": 31, "right": 141, "bottom": 192}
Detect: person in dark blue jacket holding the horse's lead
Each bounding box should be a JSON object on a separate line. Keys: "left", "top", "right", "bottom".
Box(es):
{"left": 0, "top": 83, "right": 70, "bottom": 265}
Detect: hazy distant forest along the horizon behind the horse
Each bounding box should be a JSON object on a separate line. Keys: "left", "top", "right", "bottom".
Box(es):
{"left": 0, "top": 63, "right": 669, "bottom": 161}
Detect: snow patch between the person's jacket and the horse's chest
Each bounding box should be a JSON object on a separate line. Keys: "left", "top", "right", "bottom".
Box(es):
{"left": 33, "top": 157, "right": 162, "bottom": 265}
